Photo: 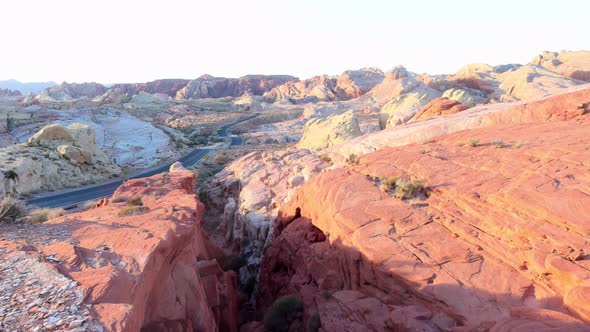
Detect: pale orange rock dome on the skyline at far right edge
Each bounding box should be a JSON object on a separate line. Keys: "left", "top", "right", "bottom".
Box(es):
{"left": 531, "top": 51, "right": 590, "bottom": 82}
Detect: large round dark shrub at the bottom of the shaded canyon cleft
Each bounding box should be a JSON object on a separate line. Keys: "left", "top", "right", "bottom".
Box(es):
{"left": 264, "top": 296, "right": 303, "bottom": 332}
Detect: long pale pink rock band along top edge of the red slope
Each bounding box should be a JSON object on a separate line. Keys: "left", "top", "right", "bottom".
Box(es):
{"left": 333, "top": 84, "right": 590, "bottom": 159}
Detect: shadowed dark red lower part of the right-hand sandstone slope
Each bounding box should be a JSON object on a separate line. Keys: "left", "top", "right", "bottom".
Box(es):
{"left": 249, "top": 209, "right": 590, "bottom": 331}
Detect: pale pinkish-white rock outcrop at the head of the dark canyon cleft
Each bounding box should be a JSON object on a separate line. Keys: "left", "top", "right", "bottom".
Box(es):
{"left": 207, "top": 149, "right": 328, "bottom": 317}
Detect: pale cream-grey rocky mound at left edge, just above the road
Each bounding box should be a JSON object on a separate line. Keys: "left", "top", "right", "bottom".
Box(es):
{"left": 0, "top": 124, "right": 121, "bottom": 194}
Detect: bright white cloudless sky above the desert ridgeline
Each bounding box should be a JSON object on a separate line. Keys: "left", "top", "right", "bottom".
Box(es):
{"left": 0, "top": 0, "right": 590, "bottom": 83}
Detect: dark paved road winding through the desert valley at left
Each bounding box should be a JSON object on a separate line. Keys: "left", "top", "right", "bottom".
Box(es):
{"left": 27, "top": 114, "right": 258, "bottom": 208}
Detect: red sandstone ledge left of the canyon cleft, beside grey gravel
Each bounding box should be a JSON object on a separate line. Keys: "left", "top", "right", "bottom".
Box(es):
{"left": 0, "top": 170, "right": 238, "bottom": 331}
